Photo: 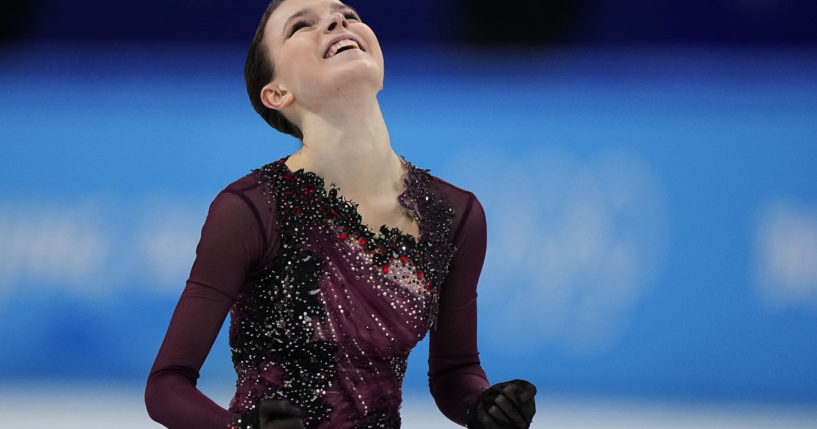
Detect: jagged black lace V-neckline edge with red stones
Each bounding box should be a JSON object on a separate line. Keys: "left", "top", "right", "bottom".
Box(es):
{"left": 279, "top": 155, "right": 425, "bottom": 245}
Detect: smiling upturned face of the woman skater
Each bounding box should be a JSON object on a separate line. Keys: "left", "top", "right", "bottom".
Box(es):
{"left": 264, "top": 0, "right": 383, "bottom": 110}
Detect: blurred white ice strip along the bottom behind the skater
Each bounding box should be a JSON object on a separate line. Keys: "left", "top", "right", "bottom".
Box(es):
{"left": 0, "top": 386, "right": 817, "bottom": 429}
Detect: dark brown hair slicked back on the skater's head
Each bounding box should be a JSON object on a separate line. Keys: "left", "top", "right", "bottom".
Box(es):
{"left": 244, "top": 0, "right": 304, "bottom": 140}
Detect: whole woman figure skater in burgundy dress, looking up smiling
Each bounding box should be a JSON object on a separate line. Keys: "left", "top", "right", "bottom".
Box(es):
{"left": 145, "top": 0, "right": 536, "bottom": 429}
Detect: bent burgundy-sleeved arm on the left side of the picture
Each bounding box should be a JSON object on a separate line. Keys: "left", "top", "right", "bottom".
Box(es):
{"left": 145, "top": 191, "right": 266, "bottom": 429}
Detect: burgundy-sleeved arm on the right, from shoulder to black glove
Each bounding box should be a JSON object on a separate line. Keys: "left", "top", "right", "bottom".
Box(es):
{"left": 428, "top": 194, "right": 490, "bottom": 426}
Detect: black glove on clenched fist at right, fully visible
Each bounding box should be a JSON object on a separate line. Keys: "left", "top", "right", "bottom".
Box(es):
{"left": 468, "top": 380, "right": 536, "bottom": 429}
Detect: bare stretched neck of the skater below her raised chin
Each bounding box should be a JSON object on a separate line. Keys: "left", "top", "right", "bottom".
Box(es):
{"left": 287, "top": 97, "right": 403, "bottom": 197}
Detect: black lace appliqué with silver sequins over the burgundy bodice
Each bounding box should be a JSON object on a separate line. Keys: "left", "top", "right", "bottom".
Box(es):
{"left": 230, "top": 158, "right": 454, "bottom": 428}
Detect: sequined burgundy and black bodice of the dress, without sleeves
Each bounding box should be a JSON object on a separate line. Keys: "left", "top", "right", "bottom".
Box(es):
{"left": 230, "top": 158, "right": 454, "bottom": 428}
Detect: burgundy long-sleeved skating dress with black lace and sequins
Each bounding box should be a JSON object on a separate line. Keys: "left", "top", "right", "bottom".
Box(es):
{"left": 145, "top": 157, "right": 489, "bottom": 429}
